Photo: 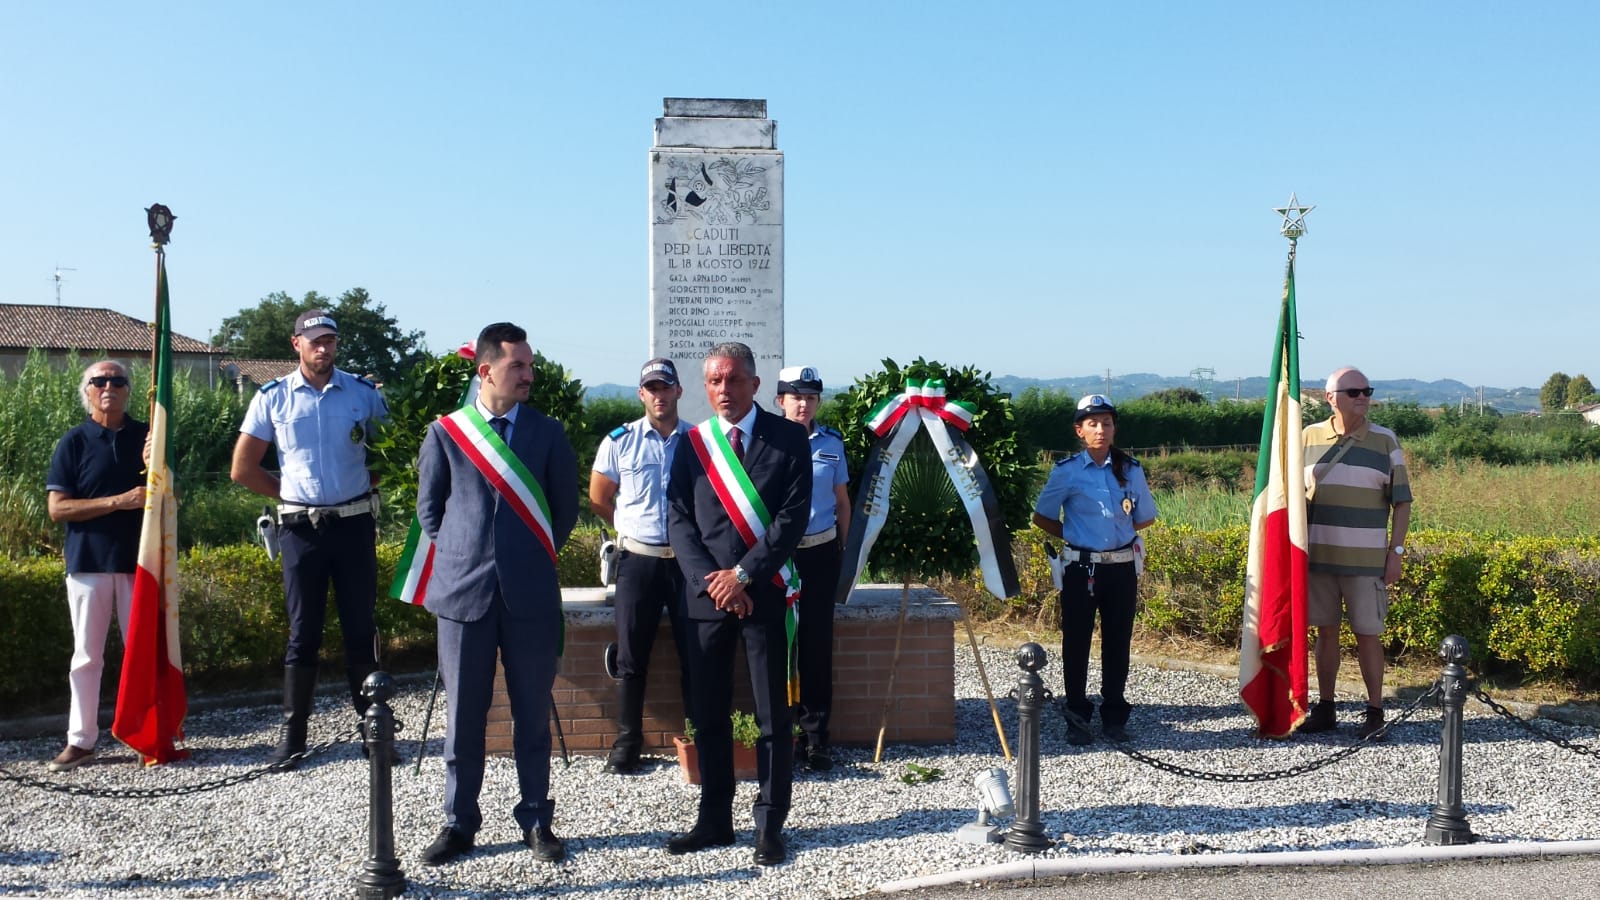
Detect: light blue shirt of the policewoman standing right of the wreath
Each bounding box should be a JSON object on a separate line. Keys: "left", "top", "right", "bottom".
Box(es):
{"left": 1034, "top": 452, "right": 1155, "bottom": 551}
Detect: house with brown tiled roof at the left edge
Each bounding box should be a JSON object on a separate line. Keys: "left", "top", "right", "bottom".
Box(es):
{"left": 0, "top": 303, "right": 222, "bottom": 381}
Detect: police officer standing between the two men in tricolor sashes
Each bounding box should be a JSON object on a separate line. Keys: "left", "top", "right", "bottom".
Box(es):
{"left": 589, "top": 359, "right": 690, "bottom": 775}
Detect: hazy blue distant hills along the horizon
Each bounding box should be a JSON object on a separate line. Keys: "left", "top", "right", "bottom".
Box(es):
{"left": 586, "top": 372, "right": 1539, "bottom": 413}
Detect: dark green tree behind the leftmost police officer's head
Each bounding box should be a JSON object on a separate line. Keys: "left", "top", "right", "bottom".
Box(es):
{"left": 216, "top": 288, "right": 429, "bottom": 383}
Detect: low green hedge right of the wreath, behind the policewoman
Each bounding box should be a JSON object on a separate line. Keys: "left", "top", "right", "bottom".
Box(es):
{"left": 941, "top": 522, "right": 1600, "bottom": 684}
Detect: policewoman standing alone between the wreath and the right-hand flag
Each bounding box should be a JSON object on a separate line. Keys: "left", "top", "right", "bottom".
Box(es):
{"left": 1034, "top": 394, "right": 1155, "bottom": 745}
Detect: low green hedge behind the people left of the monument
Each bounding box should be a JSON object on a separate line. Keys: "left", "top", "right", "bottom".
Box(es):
{"left": 0, "top": 528, "right": 600, "bottom": 711}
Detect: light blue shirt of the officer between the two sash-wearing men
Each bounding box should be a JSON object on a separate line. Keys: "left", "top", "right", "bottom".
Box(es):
{"left": 592, "top": 418, "right": 690, "bottom": 544}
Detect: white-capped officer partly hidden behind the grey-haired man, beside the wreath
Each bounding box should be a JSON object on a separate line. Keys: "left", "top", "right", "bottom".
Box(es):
{"left": 778, "top": 365, "right": 850, "bottom": 772}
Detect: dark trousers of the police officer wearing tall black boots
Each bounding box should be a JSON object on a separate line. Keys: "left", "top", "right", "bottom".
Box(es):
{"left": 278, "top": 514, "right": 378, "bottom": 669}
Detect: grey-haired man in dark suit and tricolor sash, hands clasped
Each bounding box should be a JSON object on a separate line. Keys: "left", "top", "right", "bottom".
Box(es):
{"left": 667, "top": 343, "right": 811, "bottom": 865}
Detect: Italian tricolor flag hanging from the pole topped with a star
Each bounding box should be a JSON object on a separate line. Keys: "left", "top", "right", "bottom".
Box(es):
{"left": 1238, "top": 248, "right": 1307, "bottom": 738}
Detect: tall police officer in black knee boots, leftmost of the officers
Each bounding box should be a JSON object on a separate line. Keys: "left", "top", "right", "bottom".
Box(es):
{"left": 232, "top": 309, "right": 389, "bottom": 762}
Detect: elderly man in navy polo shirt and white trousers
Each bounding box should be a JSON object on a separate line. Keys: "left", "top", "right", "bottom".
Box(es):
{"left": 45, "top": 359, "right": 150, "bottom": 772}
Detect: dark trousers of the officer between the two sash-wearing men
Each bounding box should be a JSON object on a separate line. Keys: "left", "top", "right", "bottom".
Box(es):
{"left": 613, "top": 551, "right": 690, "bottom": 756}
